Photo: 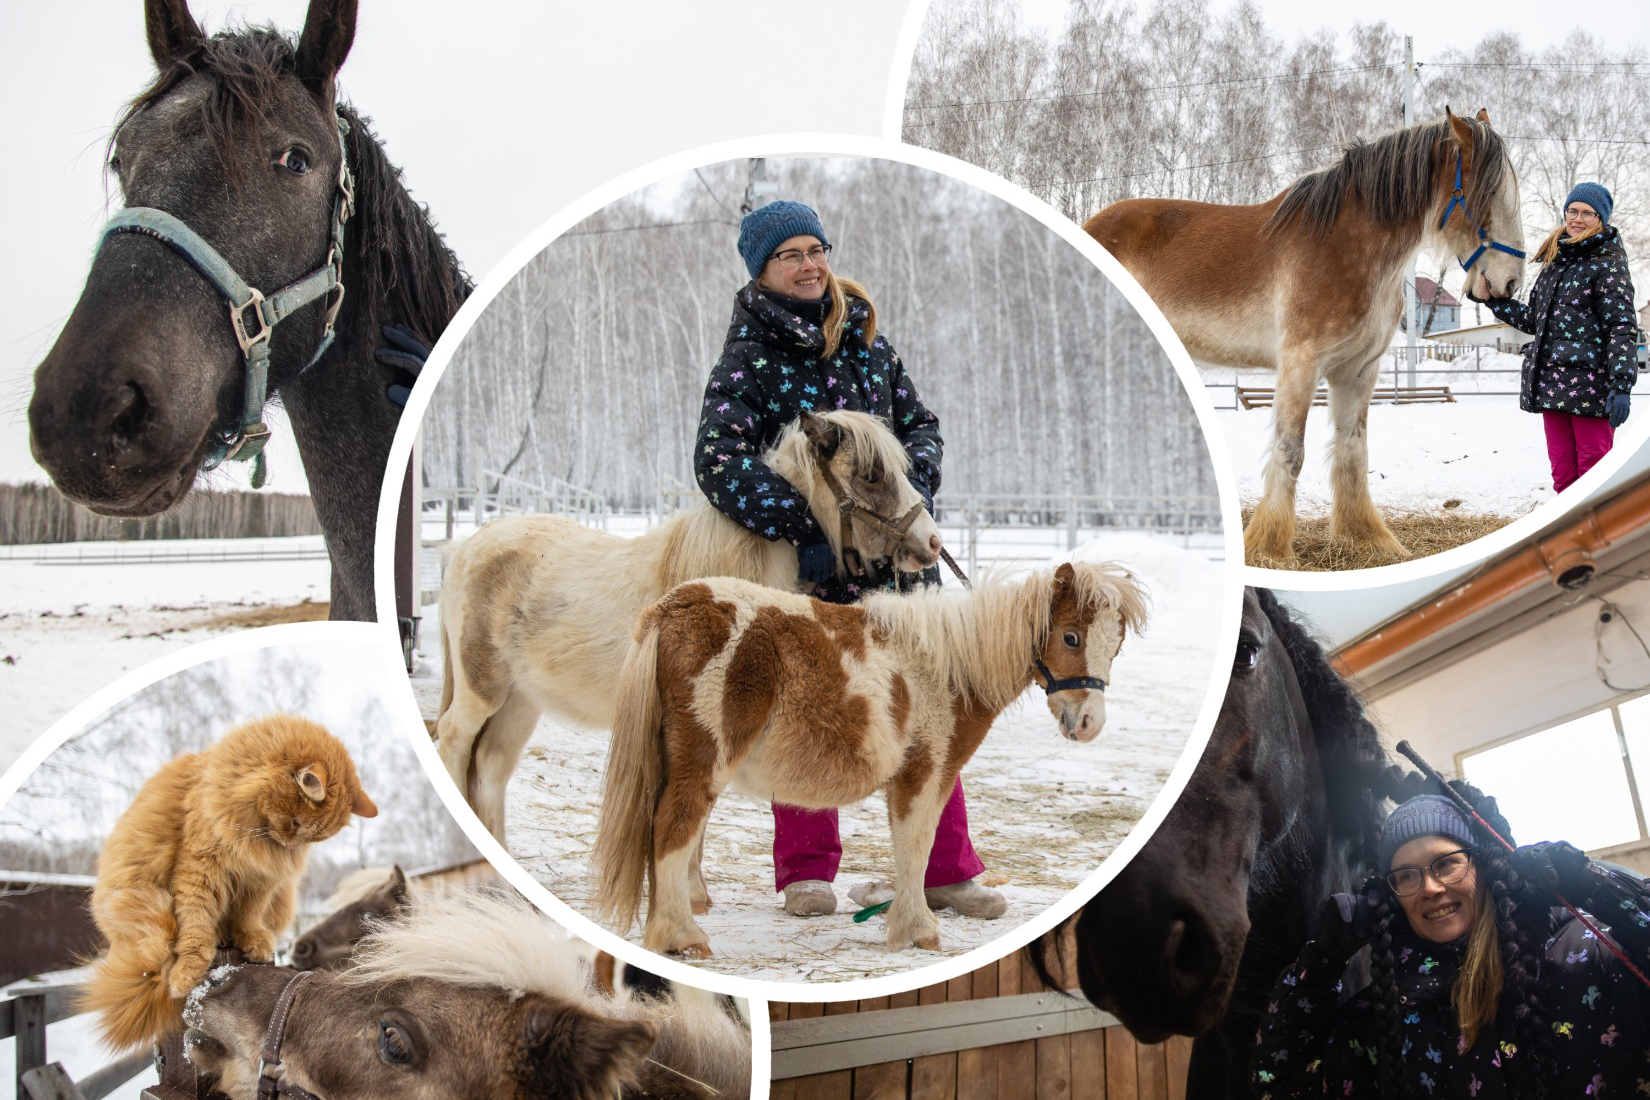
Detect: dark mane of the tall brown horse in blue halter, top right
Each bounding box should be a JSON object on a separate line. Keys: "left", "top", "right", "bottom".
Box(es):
{"left": 1266, "top": 119, "right": 1508, "bottom": 236}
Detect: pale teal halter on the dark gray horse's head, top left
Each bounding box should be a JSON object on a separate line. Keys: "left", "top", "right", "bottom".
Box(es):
{"left": 97, "top": 112, "right": 355, "bottom": 488}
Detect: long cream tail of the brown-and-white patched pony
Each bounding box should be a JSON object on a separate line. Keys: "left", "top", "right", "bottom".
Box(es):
{"left": 592, "top": 607, "right": 665, "bottom": 932}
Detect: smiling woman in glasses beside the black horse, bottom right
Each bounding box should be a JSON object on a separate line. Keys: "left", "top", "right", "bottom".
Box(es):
{"left": 1251, "top": 780, "right": 1650, "bottom": 1100}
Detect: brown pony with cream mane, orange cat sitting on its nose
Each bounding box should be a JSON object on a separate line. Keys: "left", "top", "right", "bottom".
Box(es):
{"left": 185, "top": 891, "right": 751, "bottom": 1100}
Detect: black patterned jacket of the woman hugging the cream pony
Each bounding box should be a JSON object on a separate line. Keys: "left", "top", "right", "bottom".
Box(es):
{"left": 693, "top": 282, "right": 944, "bottom": 604}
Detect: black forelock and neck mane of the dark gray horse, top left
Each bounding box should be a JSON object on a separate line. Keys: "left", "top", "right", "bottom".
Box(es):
{"left": 109, "top": 26, "right": 472, "bottom": 343}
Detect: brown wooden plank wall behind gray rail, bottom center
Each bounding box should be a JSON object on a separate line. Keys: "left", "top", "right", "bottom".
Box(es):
{"left": 767, "top": 952, "right": 1191, "bottom": 1100}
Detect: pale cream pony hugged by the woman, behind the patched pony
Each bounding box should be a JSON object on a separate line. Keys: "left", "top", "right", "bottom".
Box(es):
{"left": 436, "top": 411, "right": 941, "bottom": 841}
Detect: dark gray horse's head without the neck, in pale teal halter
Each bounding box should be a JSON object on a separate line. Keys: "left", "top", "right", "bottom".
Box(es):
{"left": 30, "top": 0, "right": 356, "bottom": 516}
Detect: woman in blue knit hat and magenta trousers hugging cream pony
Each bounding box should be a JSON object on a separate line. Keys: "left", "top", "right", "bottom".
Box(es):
{"left": 693, "top": 201, "right": 1008, "bottom": 919}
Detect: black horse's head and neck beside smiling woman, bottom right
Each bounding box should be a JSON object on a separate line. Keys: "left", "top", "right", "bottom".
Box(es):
{"left": 1030, "top": 589, "right": 1388, "bottom": 1095}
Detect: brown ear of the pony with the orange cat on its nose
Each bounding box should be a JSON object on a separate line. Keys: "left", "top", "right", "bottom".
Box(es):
{"left": 518, "top": 998, "right": 658, "bottom": 1100}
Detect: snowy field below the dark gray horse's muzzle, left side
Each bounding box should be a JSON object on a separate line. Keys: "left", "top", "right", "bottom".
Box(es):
{"left": 0, "top": 534, "right": 330, "bottom": 770}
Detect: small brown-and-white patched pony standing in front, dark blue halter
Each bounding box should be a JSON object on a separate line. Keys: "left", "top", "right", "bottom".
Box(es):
{"left": 594, "top": 564, "right": 1145, "bottom": 958}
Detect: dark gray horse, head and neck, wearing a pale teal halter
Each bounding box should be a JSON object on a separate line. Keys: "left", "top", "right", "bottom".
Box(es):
{"left": 28, "top": 0, "right": 470, "bottom": 618}
